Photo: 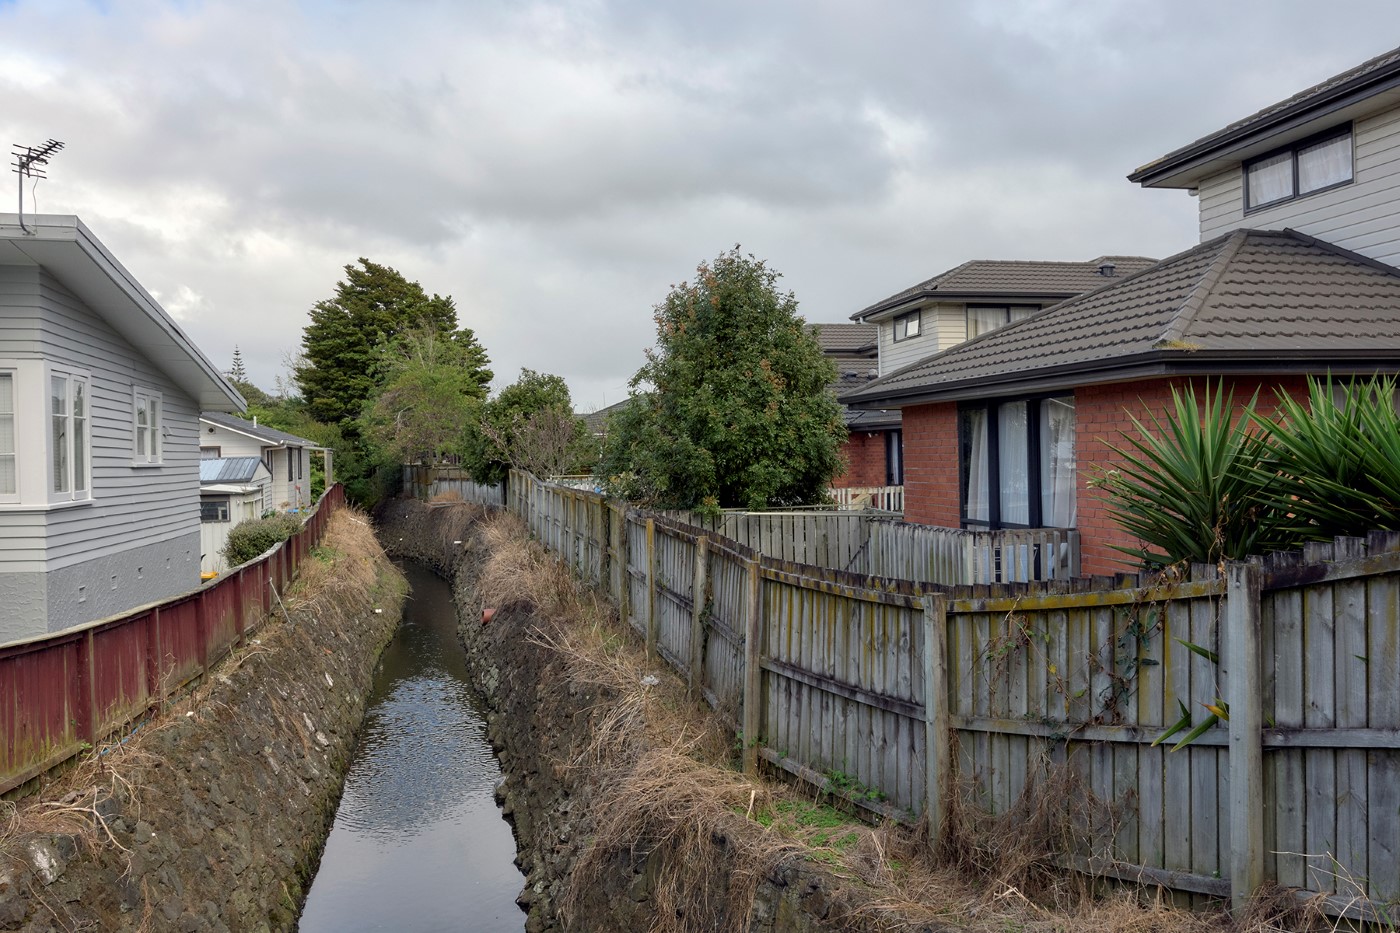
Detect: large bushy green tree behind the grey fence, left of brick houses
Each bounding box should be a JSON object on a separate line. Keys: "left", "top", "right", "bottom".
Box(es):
{"left": 601, "top": 247, "right": 846, "bottom": 509}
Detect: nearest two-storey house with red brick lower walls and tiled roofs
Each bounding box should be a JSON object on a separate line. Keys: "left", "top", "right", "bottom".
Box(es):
{"left": 843, "top": 50, "right": 1400, "bottom": 582}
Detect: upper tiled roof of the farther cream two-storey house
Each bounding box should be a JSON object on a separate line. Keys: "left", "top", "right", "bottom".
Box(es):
{"left": 851, "top": 256, "right": 1156, "bottom": 321}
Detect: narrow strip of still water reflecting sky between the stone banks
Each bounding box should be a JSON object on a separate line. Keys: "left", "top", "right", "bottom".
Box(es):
{"left": 298, "top": 563, "right": 525, "bottom": 933}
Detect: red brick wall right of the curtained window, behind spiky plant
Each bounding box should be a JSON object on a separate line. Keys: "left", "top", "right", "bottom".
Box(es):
{"left": 1074, "top": 377, "right": 1308, "bottom": 573}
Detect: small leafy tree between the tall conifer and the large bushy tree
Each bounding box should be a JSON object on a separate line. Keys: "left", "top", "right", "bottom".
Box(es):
{"left": 462, "top": 368, "right": 594, "bottom": 483}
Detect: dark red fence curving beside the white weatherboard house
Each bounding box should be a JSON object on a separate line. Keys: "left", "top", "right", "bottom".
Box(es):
{"left": 0, "top": 485, "right": 344, "bottom": 793}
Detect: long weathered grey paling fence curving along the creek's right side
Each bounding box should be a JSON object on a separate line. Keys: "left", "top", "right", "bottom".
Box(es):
{"left": 510, "top": 474, "right": 1400, "bottom": 919}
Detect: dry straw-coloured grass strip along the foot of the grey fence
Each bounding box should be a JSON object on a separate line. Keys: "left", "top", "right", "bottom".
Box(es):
{"left": 473, "top": 516, "right": 1331, "bottom": 933}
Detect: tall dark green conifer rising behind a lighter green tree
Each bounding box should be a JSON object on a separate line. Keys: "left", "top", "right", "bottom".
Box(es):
{"left": 295, "top": 258, "right": 459, "bottom": 427}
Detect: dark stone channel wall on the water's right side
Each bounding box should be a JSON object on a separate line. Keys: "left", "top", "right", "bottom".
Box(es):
{"left": 377, "top": 499, "right": 927, "bottom": 933}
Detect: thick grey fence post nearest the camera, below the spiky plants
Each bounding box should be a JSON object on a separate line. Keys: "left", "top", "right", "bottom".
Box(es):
{"left": 1225, "top": 562, "right": 1264, "bottom": 916}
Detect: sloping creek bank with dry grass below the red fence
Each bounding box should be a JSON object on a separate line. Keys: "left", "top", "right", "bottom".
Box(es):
{"left": 0, "top": 510, "right": 405, "bottom": 933}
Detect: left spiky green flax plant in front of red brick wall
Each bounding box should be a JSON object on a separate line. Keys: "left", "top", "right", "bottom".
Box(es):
{"left": 1096, "top": 384, "right": 1295, "bottom": 566}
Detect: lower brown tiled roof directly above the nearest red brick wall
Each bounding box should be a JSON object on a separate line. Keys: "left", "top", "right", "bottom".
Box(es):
{"left": 843, "top": 230, "right": 1400, "bottom": 408}
